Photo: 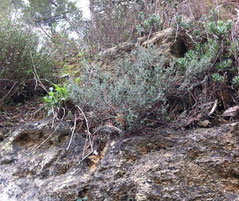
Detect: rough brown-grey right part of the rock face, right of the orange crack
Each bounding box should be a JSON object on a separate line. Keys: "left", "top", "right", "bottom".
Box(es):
{"left": 89, "top": 123, "right": 239, "bottom": 201}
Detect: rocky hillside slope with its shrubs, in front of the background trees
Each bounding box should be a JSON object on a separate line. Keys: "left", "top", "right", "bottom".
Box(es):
{"left": 0, "top": 1, "right": 239, "bottom": 201}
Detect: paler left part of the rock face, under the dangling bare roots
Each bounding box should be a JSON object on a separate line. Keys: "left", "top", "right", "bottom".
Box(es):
{"left": 0, "top": 120, "right": 88, "bottom": 201}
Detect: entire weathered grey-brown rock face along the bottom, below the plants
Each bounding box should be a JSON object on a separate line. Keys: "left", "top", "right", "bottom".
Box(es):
{"left": 0, "top": 121, "right": 239, "bottom": 201}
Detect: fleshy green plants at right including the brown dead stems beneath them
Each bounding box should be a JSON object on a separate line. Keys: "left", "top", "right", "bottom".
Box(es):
{"left": 167, "top": 10, "right": 239, "bottom": 124}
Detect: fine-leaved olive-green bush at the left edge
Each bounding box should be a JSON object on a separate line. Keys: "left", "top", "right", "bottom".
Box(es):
{"left": 0, "top": 19, "right": 54, "bottom": 100}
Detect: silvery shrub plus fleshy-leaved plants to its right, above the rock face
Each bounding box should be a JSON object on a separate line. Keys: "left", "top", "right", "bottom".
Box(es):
{"left": 44, "top": 3, "right": 238, "bottom": 130}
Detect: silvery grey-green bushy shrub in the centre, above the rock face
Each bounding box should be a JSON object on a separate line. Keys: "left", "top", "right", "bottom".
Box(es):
{"left": 66, "top": 47, "right": 177, "bottom": 129}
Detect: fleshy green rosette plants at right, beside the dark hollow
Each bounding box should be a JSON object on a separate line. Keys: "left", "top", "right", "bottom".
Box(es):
{"left": 176, "top": 10, "right": 236, "bottom": 91}
